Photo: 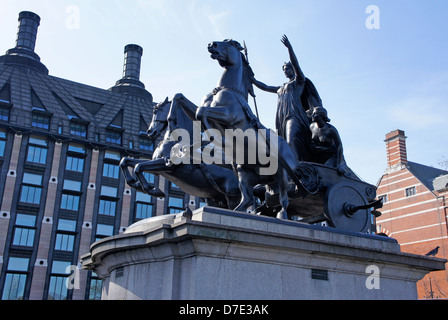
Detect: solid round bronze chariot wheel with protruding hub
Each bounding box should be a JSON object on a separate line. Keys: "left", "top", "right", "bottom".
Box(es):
{"left": 324, "top": 182, "right": 371, "bottom": 232}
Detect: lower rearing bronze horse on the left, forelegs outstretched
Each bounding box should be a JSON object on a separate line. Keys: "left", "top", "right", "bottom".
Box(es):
{"left": 120, "top": 99, "right": 241, "bottom": 209}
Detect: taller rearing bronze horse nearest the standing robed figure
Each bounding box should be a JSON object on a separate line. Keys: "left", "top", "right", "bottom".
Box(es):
{"left": 171, "top": 40, "right": 312, "bottom": 219}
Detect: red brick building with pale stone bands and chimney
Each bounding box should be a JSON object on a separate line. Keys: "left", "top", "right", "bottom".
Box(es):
{"left": 376, "top": 130, "right": 448, "bottom": 299}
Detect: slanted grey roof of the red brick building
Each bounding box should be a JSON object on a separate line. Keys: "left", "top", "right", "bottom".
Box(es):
{"left": 408, "top": 161, "right": 448, "bottom": 191}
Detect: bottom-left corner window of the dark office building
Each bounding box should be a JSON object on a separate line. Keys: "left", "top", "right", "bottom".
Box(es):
{"left": 2, "top": 257, "right": 30, "bottom": 300}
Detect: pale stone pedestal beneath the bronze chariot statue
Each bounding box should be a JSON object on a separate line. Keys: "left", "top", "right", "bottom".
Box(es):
{"left": 82, "top": 207, "right": 446, "bottom": 300}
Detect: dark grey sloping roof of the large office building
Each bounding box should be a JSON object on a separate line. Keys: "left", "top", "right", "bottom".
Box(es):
{"left": 0, "top": 63, "right": 154, "bottom": 149}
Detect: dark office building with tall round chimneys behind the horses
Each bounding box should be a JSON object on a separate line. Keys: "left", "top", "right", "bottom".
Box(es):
{"left": 0, "top": 12, "right": 200, "bottom": 300}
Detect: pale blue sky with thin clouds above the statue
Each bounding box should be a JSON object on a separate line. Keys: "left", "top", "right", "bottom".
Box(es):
{"left": 0, "top": 0, "right": 448, "bottom": 184}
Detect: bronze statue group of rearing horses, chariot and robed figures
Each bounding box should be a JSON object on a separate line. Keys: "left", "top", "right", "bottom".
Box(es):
{"left": 120, "top": 36, "right": 378, "bottom": 232}
